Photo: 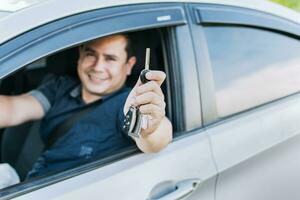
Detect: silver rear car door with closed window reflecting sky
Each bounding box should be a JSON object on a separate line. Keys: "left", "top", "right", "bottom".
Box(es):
{"left": 189, "top": 4, "right": 300, "bottom": 200}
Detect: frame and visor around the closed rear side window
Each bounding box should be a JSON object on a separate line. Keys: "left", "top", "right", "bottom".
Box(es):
{"left": 189, "top": 3, "right": 300, "bottom": 126}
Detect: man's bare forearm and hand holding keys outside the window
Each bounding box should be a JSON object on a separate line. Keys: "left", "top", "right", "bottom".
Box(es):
{"left": 124, "top": 71, "right": 173, "bottom": 153}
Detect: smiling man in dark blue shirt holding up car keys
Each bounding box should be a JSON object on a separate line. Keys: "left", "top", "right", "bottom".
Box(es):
{"left": 0, "top": 34, "right": 172, "bottom": 177}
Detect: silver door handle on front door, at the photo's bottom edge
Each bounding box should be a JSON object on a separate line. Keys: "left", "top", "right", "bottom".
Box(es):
{"left": 148, "top": 179, "right": 201, "bottom": 200}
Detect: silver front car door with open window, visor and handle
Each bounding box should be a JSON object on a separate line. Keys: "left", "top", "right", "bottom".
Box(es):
{"left": 0, "top": 3, "right": 216, "bottom": 200}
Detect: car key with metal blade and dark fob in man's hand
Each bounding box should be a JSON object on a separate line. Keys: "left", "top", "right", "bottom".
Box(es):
{"left": 123, "top": 48, "right": 150, "bottom": 138}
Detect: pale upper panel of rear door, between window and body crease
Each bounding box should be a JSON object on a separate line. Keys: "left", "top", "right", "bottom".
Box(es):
{"left": 207, "top": 92, "right": 300, "bottom": 171}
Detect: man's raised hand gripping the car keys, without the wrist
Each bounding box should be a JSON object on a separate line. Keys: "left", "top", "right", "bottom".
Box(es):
{"left": 124, "top": 70, "right": 166, "bottom": 137}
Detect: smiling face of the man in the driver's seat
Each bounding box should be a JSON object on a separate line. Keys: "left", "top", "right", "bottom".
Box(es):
{"left": 77, "top": 35, "right": 135, "bottom": 101}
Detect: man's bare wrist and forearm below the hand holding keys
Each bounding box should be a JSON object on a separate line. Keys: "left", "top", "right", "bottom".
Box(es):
{"left": 135, "top": 117, "right": 173, "bottom": 153}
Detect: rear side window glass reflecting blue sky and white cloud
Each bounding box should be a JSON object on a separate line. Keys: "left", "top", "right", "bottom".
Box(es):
{"left": 204, "top": 26, "right": 300, "bottom": 117}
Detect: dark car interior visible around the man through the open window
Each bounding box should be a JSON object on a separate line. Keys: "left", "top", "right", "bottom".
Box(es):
{"left": 0, "top": 29, "right": 168, "bottom": 181}
